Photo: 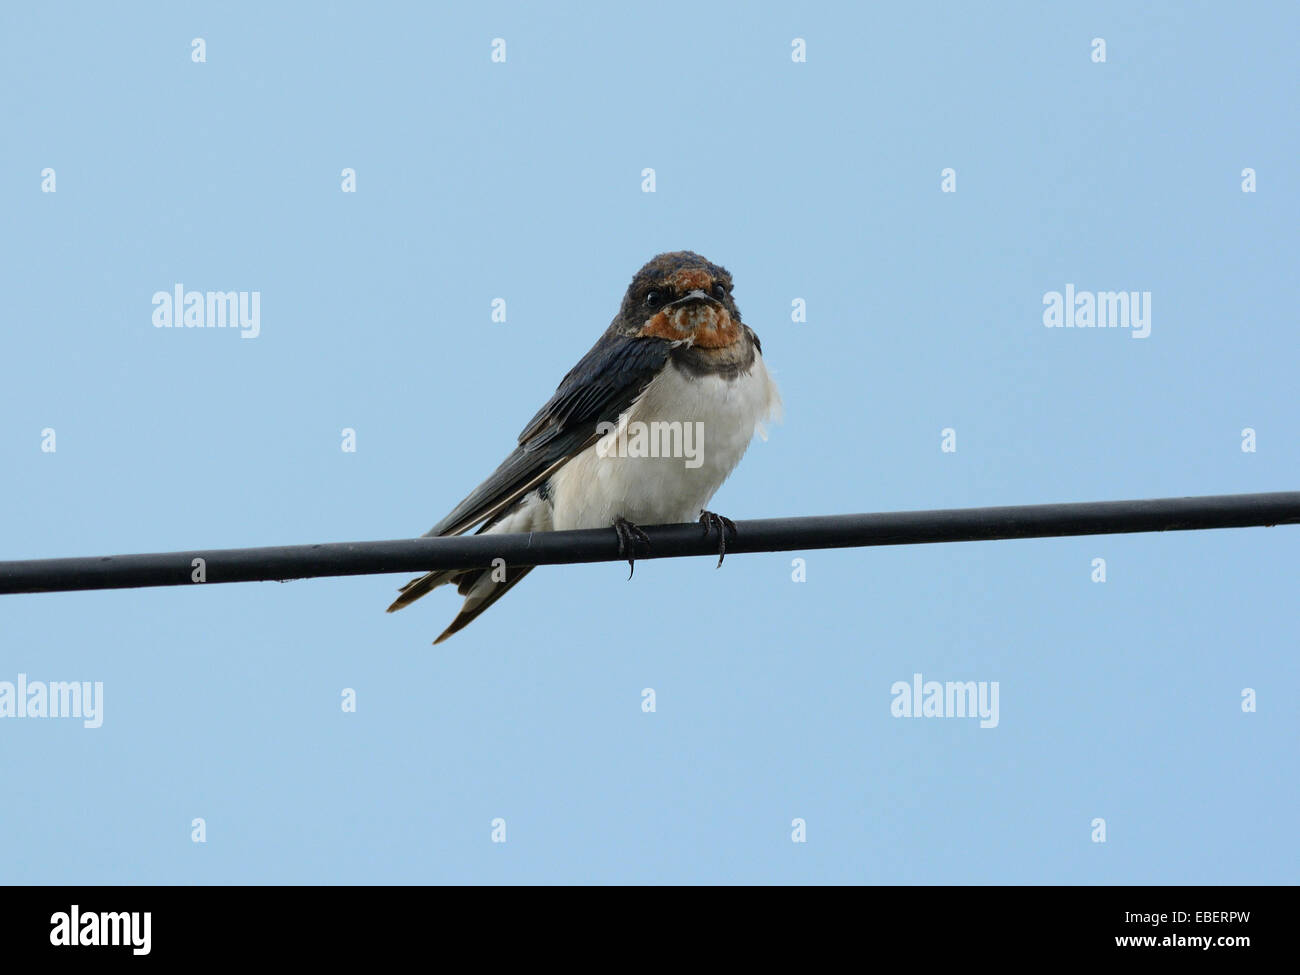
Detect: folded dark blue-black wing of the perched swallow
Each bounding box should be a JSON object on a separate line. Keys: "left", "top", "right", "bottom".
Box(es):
{"left": 426, "top": 332, "right": 672, "bottom": 536}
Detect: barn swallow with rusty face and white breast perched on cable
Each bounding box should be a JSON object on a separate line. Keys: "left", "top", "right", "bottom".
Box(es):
{"left": 389, "top": 251, "right": 781, "bottom": 644}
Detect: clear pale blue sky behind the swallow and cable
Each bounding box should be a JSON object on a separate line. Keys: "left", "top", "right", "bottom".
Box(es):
{"left": 0, "top": 3, "right": 1300, "bottom": 884}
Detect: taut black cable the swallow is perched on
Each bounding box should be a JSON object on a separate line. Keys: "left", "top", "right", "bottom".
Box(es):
{"left": 0, "top": 491, "right": 1300, "bottom": 594}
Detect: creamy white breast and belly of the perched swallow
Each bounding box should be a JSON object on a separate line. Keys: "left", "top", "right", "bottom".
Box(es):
{"left": 550, "top": 352, "right": 781, "bottom": 530}
